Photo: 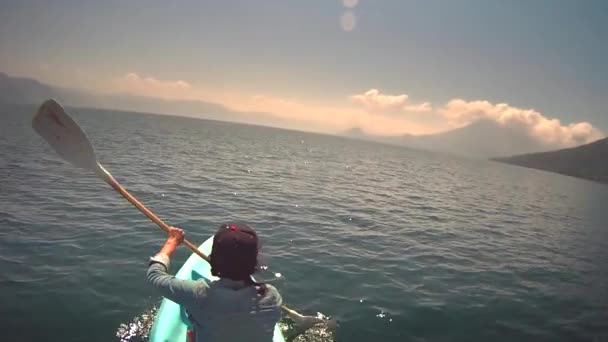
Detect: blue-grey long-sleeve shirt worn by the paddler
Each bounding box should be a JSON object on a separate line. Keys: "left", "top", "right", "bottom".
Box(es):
{"left": 147, "top": 261, "right": 283, "bottom": 342}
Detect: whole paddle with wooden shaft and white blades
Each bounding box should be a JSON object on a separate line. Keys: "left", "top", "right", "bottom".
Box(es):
{"left": 32, "top": 99, "right": 331, "bottom": 331}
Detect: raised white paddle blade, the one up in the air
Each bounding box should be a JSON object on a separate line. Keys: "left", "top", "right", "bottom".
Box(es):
{"left": 32, "top": 100, "right": 97, "bottom": 170}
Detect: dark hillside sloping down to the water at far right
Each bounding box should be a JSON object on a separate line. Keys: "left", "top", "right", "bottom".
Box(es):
{"left": 492, "top": 138, "right": 608, "bottom": 183}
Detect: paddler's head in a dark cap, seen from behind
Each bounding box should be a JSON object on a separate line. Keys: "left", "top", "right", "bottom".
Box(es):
{"left": 209, "top": 224, "right": 259, "bottom": 282}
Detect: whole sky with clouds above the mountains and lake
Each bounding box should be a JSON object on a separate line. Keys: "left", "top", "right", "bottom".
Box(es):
{"left": 0, "top": 0, "right": 608, "bottom": 146}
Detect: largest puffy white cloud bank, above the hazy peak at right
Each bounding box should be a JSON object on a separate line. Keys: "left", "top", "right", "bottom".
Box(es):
{"left": 439, "top": 99, "right": 604, "bottom": 147}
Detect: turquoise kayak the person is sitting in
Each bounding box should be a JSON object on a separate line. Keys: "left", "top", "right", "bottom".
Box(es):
{"left": 149, "top": 236, "right": 285, "bottom": 342}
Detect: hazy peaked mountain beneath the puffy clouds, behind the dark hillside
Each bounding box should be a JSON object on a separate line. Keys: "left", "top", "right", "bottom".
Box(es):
{"left": 345, "top": 120, "right": 550, "bottom": 158}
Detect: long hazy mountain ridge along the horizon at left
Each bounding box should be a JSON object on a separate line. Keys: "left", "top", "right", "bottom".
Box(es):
{"left": 0, "top": 72, "right": 287, "bottom": 126}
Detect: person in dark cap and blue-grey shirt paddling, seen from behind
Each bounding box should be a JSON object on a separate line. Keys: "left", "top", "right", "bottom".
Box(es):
{"left": 147, "top": 224, "right": 283, "bottom": 342}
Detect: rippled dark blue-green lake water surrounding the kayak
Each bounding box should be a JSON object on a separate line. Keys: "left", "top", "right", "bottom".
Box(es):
{"left": 0, "top": 105, "right": 608, "bottom": 341}
